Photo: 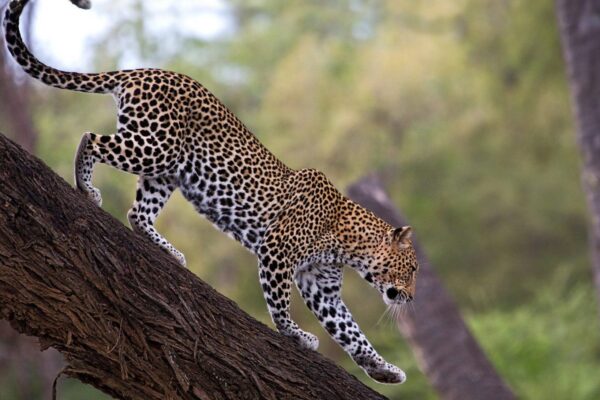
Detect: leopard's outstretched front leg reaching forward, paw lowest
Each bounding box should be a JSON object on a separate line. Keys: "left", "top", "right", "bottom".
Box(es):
{"left": 296, "top": 266, "right": 406, "bottom": 383}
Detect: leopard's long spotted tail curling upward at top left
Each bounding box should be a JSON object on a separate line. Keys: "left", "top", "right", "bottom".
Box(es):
{"left": 4, "top": 0, "right": 117, "bottom": 93}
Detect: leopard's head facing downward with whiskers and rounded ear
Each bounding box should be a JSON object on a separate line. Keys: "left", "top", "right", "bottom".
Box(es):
{"left": 364, "top": 226, "right": 419, "bottom": 305}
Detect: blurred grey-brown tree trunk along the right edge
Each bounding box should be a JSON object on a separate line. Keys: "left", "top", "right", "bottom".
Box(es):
{"left": 556, "top": 0, "right": 600, "bottom": 318}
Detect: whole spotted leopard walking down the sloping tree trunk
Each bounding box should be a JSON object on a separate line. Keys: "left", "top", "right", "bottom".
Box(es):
{"left": 3, "top": 0, "right": 419, "bottom": 384}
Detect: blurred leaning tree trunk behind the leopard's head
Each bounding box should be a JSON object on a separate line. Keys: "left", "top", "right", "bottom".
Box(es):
{"left": 348, "top": 175, "right": 515, "bottom": 400}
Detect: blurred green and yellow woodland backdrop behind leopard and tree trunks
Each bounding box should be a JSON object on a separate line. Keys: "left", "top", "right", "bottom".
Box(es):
{"left": 0, "top": 0, "right": 600, "bottom": 400}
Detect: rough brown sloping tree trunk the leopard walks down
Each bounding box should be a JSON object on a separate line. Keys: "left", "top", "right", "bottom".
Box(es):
{"left": 0, "top": 135, "right": 383, "bottom": 400}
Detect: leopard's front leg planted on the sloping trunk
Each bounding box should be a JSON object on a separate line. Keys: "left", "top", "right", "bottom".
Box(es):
{"left": 258, "top": 256, "right": 319, "bottom": 350}
